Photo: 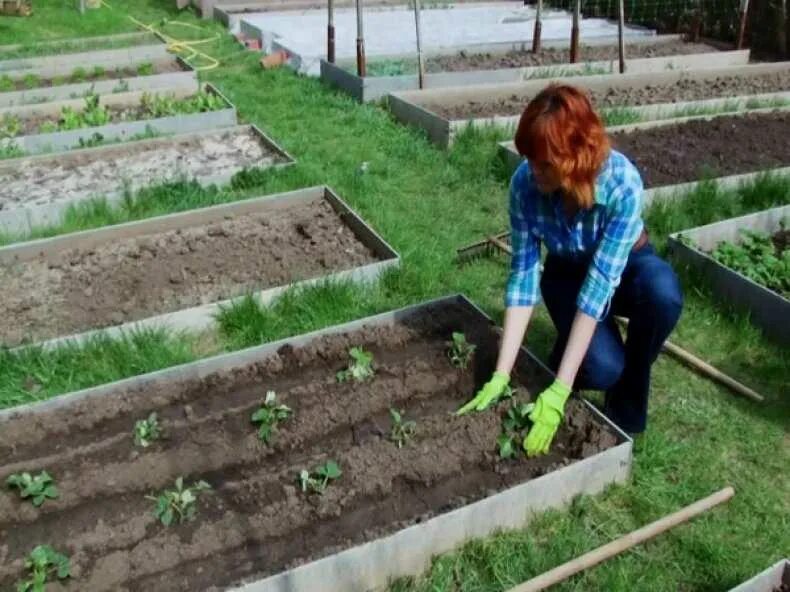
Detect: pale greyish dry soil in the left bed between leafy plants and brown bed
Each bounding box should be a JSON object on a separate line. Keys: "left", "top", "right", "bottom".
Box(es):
{"left": 0, "top": 130, "right": 285, "bottom": 211}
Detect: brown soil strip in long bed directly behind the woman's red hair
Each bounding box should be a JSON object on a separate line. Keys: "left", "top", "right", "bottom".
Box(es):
{"left": 430, "top": 69, "right": 790, "bottom": 120}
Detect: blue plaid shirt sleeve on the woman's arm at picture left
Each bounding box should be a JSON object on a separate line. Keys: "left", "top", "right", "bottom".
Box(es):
{"left": 505, "top": 163, "right": 540, "bottom": 307}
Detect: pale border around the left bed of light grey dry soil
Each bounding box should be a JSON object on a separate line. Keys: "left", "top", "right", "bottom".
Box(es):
{"left": 0, "top": 125, "right": 296, "bottom": 234}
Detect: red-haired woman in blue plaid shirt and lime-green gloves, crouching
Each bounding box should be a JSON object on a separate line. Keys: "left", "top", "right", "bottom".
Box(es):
{"left": 459, "top": 85, "right": 682, "bottom": 456}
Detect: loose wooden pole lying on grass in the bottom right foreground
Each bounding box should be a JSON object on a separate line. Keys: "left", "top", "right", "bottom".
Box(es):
{"left": 509, "top": 487, "right": 735, "bottom": 592}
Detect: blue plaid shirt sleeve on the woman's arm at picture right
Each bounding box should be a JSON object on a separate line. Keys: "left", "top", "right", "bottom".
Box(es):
{"left": 576, "top": 159, "right": 644, "bottom": 321}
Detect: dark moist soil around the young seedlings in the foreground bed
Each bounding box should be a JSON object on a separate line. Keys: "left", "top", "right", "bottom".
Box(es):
{"left": 0, "top": 305, "right": 617, "bottom": 592}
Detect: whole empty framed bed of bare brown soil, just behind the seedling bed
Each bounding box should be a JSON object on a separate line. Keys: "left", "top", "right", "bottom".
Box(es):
{"left": 0, "top": 187, "right": 397, "bottom": 346}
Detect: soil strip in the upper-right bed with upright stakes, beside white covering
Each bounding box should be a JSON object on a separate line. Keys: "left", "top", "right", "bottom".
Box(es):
{"left": 426, "top": 41, "right": 718, "bottom": 72}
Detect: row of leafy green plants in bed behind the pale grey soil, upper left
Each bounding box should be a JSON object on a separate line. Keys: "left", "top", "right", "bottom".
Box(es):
{"left": 0, "top": 91, "right": 227, "bottom": 140}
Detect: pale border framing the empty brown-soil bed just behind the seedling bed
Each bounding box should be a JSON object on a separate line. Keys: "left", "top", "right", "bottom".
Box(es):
{"left": 0, "top": 186, "right": 400, "bottom": 350}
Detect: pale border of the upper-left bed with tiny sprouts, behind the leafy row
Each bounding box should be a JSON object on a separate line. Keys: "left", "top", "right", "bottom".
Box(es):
{"left": 0, "top": 56, "right": 198, "bottom": 108}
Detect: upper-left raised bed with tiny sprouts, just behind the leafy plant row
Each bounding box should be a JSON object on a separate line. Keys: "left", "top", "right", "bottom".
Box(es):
{"left": 0, "top": 56, "right": 198, "bottom": 107}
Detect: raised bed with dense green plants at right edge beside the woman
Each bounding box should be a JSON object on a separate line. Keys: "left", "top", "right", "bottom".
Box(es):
{"left": 669, "top": 206, "right": 790, "bottom": 344}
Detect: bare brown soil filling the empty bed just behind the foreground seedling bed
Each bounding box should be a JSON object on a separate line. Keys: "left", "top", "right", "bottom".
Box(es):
{"left": 0, "top": 199, "right": 376, "bottom": 346}
